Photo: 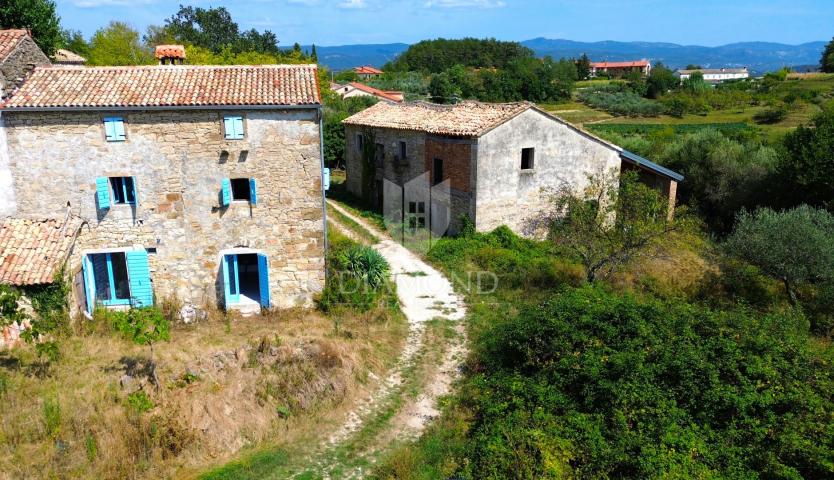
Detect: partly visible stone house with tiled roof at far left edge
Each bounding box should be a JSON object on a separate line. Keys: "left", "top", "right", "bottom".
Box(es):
{"left": 0, "top": 29, "right": 50, "bottom": 99}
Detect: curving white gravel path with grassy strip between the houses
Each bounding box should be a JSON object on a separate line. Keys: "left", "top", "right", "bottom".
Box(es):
{"left": 312, "top": 201, "right": 466, "bottom": 478}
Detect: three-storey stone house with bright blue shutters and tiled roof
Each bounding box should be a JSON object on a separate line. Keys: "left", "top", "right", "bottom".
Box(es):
{"left": 0, "top": 65, "right": 325, "bottom": 313}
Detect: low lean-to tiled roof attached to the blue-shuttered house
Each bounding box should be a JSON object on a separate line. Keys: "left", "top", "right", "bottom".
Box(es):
{"left": 0, "top": 217, "right": 81, "bottom": 285}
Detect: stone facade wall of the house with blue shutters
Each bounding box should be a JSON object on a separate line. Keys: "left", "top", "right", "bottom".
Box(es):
{"left": 3, "top": 109, "right": 324, "bottom": 307}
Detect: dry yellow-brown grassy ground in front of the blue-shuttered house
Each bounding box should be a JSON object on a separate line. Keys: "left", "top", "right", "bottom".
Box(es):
{"left": 0, "top": 310, "right": 407, "bottom": 478}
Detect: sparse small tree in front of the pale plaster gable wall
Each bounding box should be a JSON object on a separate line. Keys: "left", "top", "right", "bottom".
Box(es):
{"left": 550, "top": 172, "right": 685, "bottom": 283}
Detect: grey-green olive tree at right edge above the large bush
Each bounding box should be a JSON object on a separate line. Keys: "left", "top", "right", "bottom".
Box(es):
{"left": 726, "top": 205, "right": 834, "bottom": 305}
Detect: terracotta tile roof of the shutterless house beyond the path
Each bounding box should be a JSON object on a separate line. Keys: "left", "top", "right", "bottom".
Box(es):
{"left": 342, "top": 102, "right": 533, "bottom": 137}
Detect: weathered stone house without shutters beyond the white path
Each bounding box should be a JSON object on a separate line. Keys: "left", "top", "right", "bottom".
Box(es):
{"left": 343, "top": 102, "right": 683, "bottom": 235}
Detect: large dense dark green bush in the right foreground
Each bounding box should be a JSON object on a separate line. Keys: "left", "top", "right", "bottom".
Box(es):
{"left": 461, "top": 288, "right": 834, "bottom": 479}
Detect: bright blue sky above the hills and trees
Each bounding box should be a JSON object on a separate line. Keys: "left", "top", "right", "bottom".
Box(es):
{"left": 57, "top": 0, "right": 834, "bottom": 46}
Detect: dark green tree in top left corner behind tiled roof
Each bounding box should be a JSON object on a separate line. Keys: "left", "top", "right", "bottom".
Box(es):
{"left": 0, "top": 0, "right": 62, "bottom": 56}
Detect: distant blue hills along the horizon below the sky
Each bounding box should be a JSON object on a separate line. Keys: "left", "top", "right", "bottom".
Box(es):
{"left": 304, "top": 38, "right": 826, "bottom": 74}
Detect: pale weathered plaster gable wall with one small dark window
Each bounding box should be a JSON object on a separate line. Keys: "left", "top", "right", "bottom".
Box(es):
{"left": 475, "top": 109, "right": 620, "bottom": 236}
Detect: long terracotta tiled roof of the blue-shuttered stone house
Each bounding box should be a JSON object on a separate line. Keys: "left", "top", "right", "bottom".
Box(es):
{"left": 2, "top": 65, "right": 321, "bottom": 110}
